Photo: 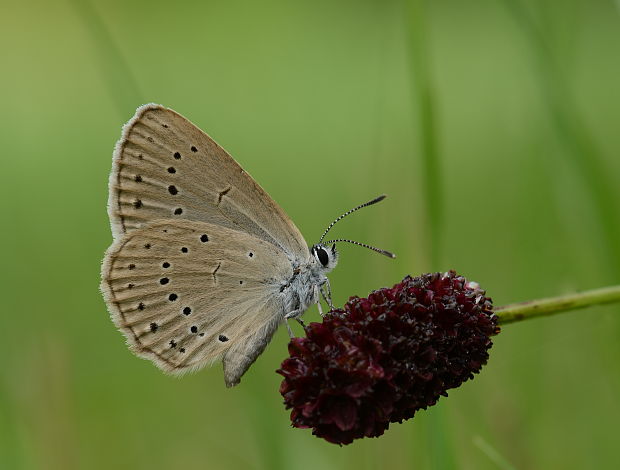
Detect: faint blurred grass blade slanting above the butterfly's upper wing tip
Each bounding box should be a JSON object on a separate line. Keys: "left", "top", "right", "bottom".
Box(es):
{"left": 70, "top": 0, "right": 146, "bottom": 118}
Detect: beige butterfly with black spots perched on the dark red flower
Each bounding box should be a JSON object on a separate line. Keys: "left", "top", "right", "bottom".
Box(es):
{"left": 101, "top": 104, "right": 394, "bottom": 387}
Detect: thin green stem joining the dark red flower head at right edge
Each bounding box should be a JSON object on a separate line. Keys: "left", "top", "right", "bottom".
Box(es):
{"left": 494, "top": 286, "right": 620, "bottom": 325}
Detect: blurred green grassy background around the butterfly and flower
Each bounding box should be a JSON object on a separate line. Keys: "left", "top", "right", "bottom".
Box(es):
{"left": 0, "top": 0, "right": 620, "bottom": 470}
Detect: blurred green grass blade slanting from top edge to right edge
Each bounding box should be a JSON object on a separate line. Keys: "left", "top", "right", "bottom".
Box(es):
{"left": 502, "top": 0, "right": 620, "bottom": 282}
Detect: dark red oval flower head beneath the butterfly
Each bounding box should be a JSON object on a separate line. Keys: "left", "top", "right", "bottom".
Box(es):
{"left": 277, "top": 271, "right": 499, "bottom": 444}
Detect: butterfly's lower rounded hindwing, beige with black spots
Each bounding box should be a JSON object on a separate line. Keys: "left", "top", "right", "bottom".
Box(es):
{"left": 101, "top": 220, "right": 292, "bottom": 386}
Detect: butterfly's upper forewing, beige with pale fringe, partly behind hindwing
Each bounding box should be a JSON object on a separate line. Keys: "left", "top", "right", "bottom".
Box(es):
{"left": 108, "top": 104, "right": 309, "bottom": 259}
